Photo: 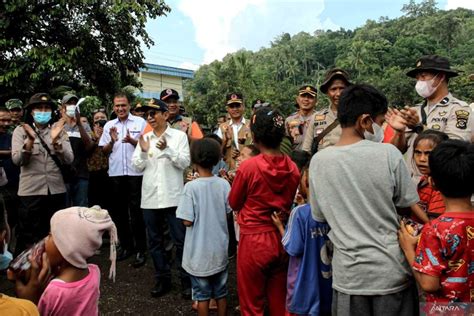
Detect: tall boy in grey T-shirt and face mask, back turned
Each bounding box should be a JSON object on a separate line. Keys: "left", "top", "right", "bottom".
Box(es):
{"left": 309, "top": 85, "right": 418, "bottom": 316}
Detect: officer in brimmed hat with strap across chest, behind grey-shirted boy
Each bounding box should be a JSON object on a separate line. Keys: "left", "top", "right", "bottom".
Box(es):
{"left": 302, "top": 68, "right": 351, "bottom": 154}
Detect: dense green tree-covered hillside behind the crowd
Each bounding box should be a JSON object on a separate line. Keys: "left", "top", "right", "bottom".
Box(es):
{"left": 186, "top": 0, "right": 474, "bottom": 125}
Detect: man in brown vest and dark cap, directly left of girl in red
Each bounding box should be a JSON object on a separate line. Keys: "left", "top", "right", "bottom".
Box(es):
{"left": 216, "top": 93, "right": 252, "bottom": 169}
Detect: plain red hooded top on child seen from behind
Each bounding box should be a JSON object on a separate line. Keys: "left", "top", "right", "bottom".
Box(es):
{"left": 229, "top": 154, "right": 300, "bottom": 234}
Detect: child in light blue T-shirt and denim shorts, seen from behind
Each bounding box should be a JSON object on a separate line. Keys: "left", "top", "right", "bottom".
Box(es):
{"left": 176, "top": 138, "right": 231, "bottom": 315}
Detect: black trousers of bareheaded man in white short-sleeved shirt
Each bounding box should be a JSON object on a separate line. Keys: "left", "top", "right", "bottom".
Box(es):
{"left": 110, "top": 176, "right": 146, "bottom": 252}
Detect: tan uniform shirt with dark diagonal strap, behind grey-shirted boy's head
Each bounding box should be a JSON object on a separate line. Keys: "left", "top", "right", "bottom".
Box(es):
{"left": 301, "top": 107, "right": 342, "bottom": 153}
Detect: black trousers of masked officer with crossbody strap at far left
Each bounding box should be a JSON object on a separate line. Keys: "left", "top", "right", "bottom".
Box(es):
{"left": 15, "top": 193, "right": 66, "bottom": 254}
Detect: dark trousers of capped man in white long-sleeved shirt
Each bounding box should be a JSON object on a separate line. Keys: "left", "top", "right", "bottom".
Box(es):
{"left": 143, "top": 207, "right": 190, "bottom": 286}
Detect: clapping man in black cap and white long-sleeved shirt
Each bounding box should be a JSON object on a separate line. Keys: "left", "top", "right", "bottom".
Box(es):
{"left": 132, "top": 98, "right": 191, "bottom": 298}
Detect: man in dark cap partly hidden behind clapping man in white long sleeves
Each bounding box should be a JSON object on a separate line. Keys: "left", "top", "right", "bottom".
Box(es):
{"left": 160, "top": 89, "right": 204, "bottom": 140}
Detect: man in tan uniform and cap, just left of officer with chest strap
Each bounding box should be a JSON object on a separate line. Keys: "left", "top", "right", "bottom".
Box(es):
{"left": 285, "top": 85, "right": 318, "bottom": 150}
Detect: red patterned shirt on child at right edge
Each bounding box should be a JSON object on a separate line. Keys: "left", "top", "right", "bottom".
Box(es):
{"left": 413, "top": 212, "right": 474, "bottom": 303}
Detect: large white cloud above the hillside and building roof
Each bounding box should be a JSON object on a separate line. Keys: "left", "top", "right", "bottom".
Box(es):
{"left": 178, "top": 0, "right": 339, "bottom": 63}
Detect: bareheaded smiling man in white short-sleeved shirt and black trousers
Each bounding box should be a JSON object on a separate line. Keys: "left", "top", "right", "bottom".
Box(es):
{"left": 99, "top": 92, "right": 150, "bottom": 268}
